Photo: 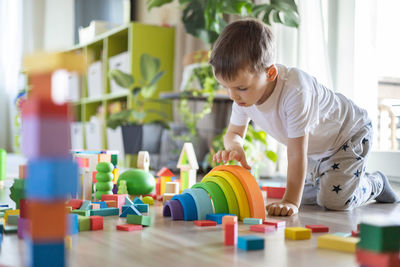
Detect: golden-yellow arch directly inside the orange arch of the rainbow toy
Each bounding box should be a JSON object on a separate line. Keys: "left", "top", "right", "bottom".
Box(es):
{"left": 205, "top": 171, "right": 251, "bottom": 220}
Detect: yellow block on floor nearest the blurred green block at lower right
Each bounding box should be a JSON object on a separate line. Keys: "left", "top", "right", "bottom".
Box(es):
{"left": 317, "top": 234, "right": 360, "bottom": 253}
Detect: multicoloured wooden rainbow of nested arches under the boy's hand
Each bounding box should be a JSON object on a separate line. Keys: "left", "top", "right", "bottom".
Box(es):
{"left": 163, "top": 165, "right": 265, "bottom": 221}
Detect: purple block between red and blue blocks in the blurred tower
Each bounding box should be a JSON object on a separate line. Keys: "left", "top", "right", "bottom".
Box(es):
{"left": 22, "top": 116, "right": 71, "bottom": 158}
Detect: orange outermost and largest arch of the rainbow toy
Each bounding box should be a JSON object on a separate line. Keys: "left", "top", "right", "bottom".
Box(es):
{"left": 211, "top": 165, "right": 265, "bottom": 219}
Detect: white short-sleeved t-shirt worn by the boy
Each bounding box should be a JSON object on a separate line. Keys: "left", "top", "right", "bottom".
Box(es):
{"left": 230, "top": 65, "right": 370, "bottom": 158}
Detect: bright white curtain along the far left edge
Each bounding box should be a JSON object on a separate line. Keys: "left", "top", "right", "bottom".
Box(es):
{"left": 0, "top": 0, "right": 22, "bottom": 151}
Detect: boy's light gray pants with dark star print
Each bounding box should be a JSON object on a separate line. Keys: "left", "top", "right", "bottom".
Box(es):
{"left": 301, "top": 124, "right": 383, "bottom": 210}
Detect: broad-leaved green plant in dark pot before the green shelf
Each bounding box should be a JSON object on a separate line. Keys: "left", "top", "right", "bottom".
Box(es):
{"left": 107, "top": 54, "right": 169, "bottom": 129}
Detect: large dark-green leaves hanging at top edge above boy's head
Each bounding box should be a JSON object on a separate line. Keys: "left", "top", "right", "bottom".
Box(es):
{"left": 147, "top": 0, "right": 299, "bottom": 44}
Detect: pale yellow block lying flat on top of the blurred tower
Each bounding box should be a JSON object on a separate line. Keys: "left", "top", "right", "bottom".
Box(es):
{"left": 23, "top": 52, "right": 86, "bottom": 74}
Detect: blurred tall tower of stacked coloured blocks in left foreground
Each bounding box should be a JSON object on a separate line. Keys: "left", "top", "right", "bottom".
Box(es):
{"left": 22, "top": 53, "right": 85, "bottom": 266}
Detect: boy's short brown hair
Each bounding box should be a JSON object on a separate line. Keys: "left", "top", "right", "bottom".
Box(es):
{"left": 209, "top": 19, "right": 275, "bottom": 81}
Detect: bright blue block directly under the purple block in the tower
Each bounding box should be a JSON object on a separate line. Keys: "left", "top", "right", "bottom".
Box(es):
{"left": 26, "top": 158, "right": 78, "bottom": 200}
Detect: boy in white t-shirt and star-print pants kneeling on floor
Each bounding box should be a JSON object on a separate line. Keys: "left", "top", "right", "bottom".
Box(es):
{"left": 210, "top": 19, "right": 399, "bottom": 216}
